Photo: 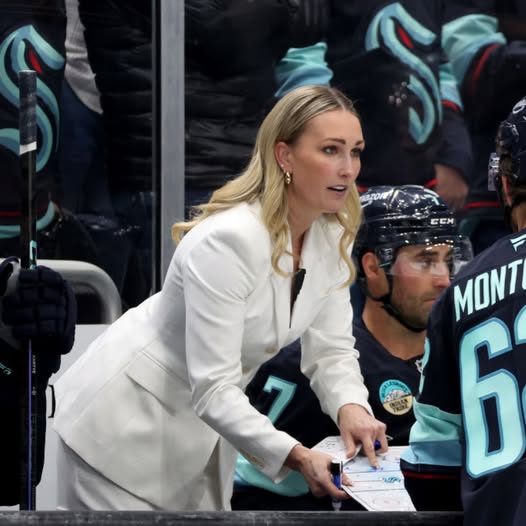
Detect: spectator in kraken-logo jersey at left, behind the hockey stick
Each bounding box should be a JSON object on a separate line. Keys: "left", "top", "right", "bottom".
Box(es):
{"left": 0, "top": 0, "right": 66, "bottom": 257}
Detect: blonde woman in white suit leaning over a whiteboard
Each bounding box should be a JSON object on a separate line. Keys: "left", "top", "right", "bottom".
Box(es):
{"left": 55, "top": 86, "right": 387, "bottom": 510}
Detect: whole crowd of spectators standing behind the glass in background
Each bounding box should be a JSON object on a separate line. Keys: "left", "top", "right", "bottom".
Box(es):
{"left": 0, "top": 0, "right": 526, "bottom": 315}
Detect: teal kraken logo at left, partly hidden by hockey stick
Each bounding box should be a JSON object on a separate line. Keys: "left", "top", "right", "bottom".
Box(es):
{"left": 0, "top": 25, "right": 64, "bottom": 172}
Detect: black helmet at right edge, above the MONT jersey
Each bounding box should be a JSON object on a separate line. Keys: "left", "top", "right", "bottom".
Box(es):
{"left": 488, "top": 97, "right": 526, "bottom": 206}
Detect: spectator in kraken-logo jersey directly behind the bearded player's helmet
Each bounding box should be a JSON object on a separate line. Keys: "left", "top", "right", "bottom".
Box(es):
{"left": 278, "top": 0, "right": 472, "bottom": 210}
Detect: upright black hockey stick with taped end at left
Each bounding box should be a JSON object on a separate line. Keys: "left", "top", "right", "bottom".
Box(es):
{"left": 18, "top": 70, "right": 37, "bottom": 510}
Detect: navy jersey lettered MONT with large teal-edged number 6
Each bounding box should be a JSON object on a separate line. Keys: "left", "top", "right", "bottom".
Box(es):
{"left": 402, "top": 230, "right": 526, "bottom": 526}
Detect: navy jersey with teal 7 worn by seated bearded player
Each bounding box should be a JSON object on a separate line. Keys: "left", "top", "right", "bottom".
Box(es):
{"left": 236, "top": 318, "right": 420, "bottom": 504}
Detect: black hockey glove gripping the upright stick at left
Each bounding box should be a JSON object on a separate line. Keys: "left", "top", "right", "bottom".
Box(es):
{"left": 0, "top": 262, "right": 77, "bottom": 357}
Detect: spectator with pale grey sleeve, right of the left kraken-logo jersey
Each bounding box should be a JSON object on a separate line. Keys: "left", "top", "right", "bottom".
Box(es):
{"left": 59, "top": 0, "right": 129, "bottom": 323}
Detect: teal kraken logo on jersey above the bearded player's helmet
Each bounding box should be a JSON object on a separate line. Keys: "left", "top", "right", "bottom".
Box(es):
{"left": 365, "top": 3, "right": 442, "bottom": 144}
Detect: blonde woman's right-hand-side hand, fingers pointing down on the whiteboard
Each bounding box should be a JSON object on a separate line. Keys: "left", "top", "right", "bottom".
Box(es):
{"left": 338, "top": 404, "right": 388, "bottom": 468}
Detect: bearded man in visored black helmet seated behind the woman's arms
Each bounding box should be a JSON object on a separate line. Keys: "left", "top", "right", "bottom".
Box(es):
{"left": 232, "top": 185, "right": 471, "bottom": 510}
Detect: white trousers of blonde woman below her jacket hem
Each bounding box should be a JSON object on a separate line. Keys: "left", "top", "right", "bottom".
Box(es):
{"left": 57, "top": 438, "right": 159, "bottom": 511}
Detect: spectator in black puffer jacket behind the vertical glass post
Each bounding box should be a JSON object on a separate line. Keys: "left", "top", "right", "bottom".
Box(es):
{"left": 75, "top": 0, "right": 326, "bottom": 307}
